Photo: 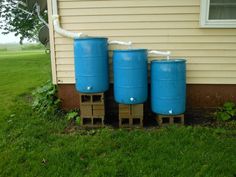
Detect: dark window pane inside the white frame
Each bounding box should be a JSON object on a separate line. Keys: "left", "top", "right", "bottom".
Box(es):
{"left": 209, "top": 0, "right": 236, "bottom": 20}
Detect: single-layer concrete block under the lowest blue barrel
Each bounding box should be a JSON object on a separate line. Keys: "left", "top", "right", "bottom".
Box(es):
{"left": 156, "top": 114, "right": 184, "bottom": 126}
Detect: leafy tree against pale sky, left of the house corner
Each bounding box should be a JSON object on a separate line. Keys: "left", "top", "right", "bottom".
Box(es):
{"left": 0, "top": 0, "right": 47, "bottom": 43}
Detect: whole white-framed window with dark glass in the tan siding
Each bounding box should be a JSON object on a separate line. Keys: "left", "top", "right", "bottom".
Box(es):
{"left": 200, "top": 0, "right": 236, "bottom": 28}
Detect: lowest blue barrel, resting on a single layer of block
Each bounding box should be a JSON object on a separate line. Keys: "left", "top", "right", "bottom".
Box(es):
{"left": 151, "top": 59, "right": 186, "bottom": 115}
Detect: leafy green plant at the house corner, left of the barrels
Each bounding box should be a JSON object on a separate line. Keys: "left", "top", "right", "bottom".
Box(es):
{"left": 32, "top": 81, "right": 60, "bottom": 115}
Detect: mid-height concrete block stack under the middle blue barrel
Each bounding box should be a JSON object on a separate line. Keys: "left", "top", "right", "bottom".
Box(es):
{"left": 119, "top": 104, "right": 143, "bottom": 128}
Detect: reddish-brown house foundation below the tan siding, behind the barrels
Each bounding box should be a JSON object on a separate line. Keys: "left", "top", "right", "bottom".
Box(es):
{"left": 58, "top": 84, "right": 236, "bottom": 119}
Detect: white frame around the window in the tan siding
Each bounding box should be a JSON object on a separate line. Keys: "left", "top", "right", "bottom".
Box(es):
{"left": 200, "top": 0, "right": 236, "bottom": 28}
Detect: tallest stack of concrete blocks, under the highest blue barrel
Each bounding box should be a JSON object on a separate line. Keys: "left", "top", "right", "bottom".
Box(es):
{"left": 80, "top": 93, "right": 105, "bottom": 128}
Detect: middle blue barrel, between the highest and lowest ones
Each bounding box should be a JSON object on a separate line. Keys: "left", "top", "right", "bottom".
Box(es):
{"left": 113, "top": 49, "right": 148, "bottom": 104}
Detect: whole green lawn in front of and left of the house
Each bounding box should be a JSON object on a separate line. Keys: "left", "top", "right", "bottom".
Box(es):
{"left": 0, "top": 52, "right": 236, "bottom": 177}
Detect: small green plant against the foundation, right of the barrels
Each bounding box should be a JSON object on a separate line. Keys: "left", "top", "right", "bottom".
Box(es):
{"left": 214, "top": 102, "right": 236, "bottom": 121}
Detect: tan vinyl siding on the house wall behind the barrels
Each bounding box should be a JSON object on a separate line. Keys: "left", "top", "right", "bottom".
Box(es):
{"left": 49, "top": 0, "right": 236, "bottom": 84}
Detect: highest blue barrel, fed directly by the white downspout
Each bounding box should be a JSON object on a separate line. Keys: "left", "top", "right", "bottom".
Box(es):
{"left": 74, "top": 37, "right": 109, "bottom": 93}
